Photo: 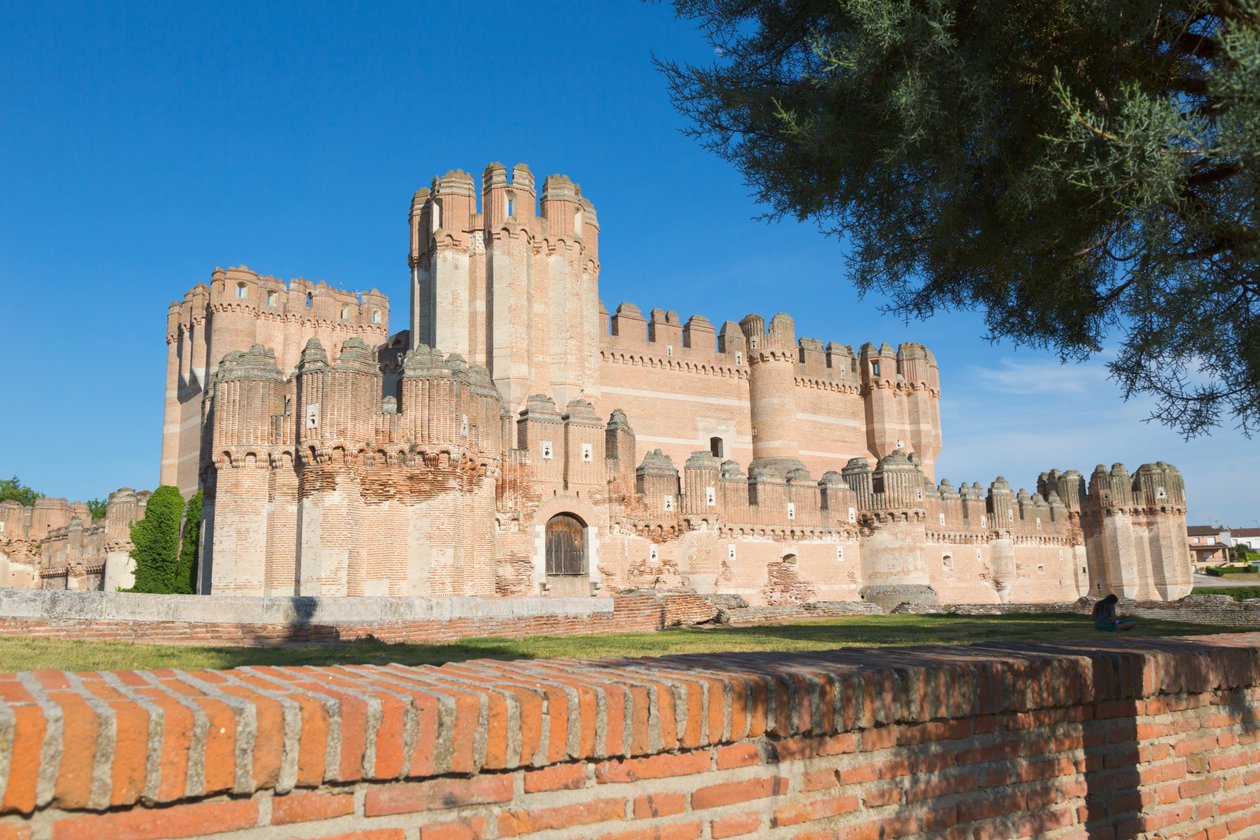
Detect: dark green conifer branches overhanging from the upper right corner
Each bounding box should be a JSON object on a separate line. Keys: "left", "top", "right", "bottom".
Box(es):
{"left": 658, "top": 0, "right": 1260, "bottom": 436}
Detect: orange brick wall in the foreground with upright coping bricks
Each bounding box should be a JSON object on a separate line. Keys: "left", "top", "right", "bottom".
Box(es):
{"left": 0, "top": 633, "right": 1260, "bottom": 840}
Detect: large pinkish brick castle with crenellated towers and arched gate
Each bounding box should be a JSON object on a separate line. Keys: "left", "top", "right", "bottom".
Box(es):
{"left": 7, "top": 164, "right": 1191, "bottom": 604}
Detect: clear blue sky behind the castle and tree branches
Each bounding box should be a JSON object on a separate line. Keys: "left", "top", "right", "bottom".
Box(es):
{"left": 0, "top": 0, "right": 1260, "bottom": 526}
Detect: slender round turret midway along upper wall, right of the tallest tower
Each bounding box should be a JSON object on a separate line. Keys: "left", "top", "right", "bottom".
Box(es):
{"left": 740, "top": 312, "right": 805, "bottom": 475}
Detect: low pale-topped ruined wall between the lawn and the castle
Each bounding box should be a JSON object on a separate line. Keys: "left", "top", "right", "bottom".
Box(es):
{"left": 0, "top": 589, "right": 1260, "bottom": 647}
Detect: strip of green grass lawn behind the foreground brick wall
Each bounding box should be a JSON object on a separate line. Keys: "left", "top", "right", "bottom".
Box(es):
{"left": 0, "top": 615, "right": 1239, "bottom": 673}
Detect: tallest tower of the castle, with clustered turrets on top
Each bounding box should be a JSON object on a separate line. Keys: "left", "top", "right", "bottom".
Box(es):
{"left": 408, "top": 164, "right": 600, "bottom": 413}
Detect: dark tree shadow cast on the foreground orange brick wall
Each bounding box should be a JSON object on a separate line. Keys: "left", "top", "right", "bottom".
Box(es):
{"left": 622, "top": 637, "right": 1260, "bottom": 840}
